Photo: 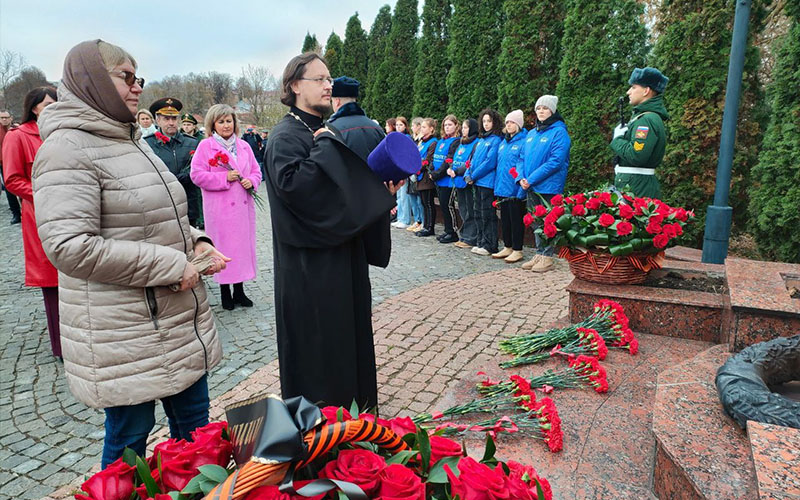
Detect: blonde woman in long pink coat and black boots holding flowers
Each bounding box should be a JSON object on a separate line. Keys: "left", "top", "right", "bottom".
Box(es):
{"left": 191, "top": 104, "right": 261, "bottom": 310}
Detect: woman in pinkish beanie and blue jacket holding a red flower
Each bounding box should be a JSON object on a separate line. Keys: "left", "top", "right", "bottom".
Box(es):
{"left": 492, "top": 109, "right": 528, "bottom": 264}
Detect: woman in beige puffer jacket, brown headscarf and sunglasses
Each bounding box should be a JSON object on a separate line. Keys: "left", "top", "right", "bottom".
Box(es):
{"left": 33, "top": 40, "right": 224, "bottom": 467}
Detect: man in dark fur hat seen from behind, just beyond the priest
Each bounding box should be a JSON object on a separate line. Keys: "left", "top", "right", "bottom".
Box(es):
{"left": 328, "top": 76, "right": 386, "bottom": 161}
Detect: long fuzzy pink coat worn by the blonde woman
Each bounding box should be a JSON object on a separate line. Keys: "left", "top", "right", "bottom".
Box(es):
{"left": 191, "top": 137, "right": 261, "bottom": 284}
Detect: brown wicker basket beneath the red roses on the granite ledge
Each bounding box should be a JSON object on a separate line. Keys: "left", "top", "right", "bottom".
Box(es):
{"left": 558, "top": 247, "right": 664, "bottom": 285}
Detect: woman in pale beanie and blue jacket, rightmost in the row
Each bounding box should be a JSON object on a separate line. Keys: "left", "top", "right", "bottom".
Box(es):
{"left": 517, "top": 95, "right": 572, "bottom": 272}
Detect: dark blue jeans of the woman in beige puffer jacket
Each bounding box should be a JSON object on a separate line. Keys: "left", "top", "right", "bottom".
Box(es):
{"left": 102, "top": 375, "right": 209, "bottom": 469}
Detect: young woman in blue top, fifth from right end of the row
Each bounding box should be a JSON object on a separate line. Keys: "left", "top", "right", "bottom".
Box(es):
{"left": 431, "top": 115, "right": 459, "bottom": 243}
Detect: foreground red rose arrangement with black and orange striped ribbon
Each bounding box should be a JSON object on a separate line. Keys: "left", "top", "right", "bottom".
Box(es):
{"left": 75, "top": 397, "right": 552, "bottom": 500}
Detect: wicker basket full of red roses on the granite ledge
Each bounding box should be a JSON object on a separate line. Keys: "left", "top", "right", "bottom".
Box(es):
{"left": 525, "top": 187, "right": 694, "bottom": 284}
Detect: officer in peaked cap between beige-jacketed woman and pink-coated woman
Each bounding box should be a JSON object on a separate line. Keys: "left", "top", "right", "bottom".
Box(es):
{"left": 144, "top": 97, "right": 200, "bottom": 227}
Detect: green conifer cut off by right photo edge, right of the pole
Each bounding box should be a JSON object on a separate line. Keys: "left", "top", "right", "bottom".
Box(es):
{"left": 749, "top": 0, "right": 800, "bottom": 262}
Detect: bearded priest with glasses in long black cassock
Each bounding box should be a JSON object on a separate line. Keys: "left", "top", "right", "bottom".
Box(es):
{"left": 264, "top": 52, "right": 397, "bottom": 408}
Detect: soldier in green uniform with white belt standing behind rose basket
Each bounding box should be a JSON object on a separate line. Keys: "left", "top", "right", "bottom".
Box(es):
{"left": 610, "top": 67, "right": 669, "bottom": 198}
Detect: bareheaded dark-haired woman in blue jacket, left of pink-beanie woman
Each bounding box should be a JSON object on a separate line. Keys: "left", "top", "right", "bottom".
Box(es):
{"left": 464, "top": 109, "right": 503, "bottom": 255}
